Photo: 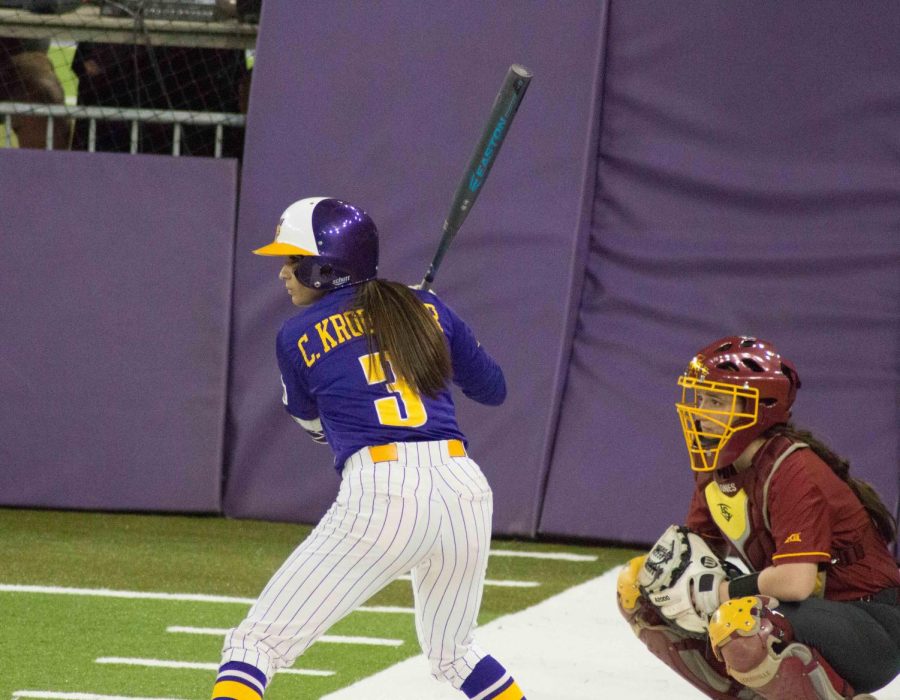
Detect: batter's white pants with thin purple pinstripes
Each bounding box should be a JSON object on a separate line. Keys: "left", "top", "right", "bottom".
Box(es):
{"left": 223, "top": 440, "right": 493, "bottom": 688}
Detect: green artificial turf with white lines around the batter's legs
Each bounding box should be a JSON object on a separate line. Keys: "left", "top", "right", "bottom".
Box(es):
{"left": 0, "top": 509, "right": 635, "bottom": 700}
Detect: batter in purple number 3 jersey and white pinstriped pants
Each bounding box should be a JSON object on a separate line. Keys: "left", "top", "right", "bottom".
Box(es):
{"left": 212, "top": 197, "right": 524, "bottom": 700}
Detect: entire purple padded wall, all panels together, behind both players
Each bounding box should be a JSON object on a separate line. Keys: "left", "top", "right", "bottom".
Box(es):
{"left": 0, "top": 0, "right": 900, "bottom": 542}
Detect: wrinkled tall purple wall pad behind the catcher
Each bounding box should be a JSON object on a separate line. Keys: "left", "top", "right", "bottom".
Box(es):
{"left": 541, "top": 0, "right": 900, "bottom": 542}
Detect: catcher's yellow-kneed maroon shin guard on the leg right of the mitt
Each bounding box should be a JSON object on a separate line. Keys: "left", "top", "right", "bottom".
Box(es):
{"left": 709, "top": 596, "right": 853, "bottom": 700}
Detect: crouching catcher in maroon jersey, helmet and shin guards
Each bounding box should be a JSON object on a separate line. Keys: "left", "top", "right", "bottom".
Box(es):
{"left": 617, "top": 337, "right": 900, "bottom": 700}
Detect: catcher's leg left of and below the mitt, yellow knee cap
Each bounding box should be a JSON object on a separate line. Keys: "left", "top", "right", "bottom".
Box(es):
{"left": 616, "top": 557, "right": 760, "bottom": 700}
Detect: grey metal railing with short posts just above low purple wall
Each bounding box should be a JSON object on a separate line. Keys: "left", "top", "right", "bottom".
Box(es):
{"left": 0, "top": 102, "right": 247, "bottom": 158}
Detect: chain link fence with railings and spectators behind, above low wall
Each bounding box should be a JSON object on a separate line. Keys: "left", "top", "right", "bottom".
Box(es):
{"left": 0, "top": 0, "right": 261, "bottom": 158}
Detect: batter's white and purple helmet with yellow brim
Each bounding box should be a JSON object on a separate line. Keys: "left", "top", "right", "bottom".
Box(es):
{"left": 253, "top": 197, "right": 378, "bottom": 290}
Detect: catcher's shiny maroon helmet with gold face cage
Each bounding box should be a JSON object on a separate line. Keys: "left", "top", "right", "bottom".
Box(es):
{"left": 675, "top": 336, "right": 800, "bottom": 471}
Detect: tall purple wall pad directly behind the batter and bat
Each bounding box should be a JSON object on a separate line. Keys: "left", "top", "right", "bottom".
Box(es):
{"left": 225, "top": 0, "right": 605, "bottom": 533}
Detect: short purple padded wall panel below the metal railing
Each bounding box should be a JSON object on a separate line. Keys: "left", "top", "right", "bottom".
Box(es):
{"left": 0, "top": 149, "right": 237, "bottom": 512}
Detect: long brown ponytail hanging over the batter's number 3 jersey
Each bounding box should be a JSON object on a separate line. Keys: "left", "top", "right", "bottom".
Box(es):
{"left": 355, "top": 279, "right": 453, "bottom": 398}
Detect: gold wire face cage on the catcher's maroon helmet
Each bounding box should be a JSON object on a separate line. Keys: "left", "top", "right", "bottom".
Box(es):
{"left": 675, "top": 374, "right": 759, "bottom": 472}
